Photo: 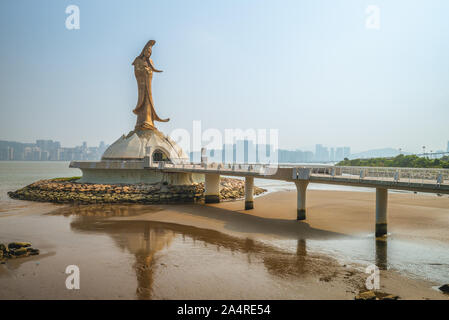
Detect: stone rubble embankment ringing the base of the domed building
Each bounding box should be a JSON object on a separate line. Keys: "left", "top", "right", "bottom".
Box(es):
{"left": 8, "top": 178, "right": 266, "bottom": 204}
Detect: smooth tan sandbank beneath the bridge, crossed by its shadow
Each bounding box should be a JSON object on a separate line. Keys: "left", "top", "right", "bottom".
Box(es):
{"left": 139, "top": 190, "right": 449, "bottom": 247}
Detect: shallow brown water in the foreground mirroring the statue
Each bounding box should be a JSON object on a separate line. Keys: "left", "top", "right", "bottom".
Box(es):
{"left": 0, "top": 206, "right": 346, "bottom": 299}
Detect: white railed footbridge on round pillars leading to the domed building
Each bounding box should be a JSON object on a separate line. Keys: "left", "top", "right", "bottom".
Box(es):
{"left": 70, "top": 157, "right": 449, "bottom": 236}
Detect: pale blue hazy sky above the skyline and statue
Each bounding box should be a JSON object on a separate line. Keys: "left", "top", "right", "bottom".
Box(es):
{"left": 0, "top": 0, "right": 449, "bottom": 151}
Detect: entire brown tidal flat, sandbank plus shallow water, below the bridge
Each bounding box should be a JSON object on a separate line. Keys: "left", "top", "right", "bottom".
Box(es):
{"left": 0, "top": 190, "right": 449, "bottom": 299}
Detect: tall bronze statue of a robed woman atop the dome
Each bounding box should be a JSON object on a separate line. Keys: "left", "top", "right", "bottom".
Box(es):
{"left": 133, "top": 40, "right": 170, "bottom": 130}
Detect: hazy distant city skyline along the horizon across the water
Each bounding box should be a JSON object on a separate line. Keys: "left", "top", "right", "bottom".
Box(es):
{"left": 0, "top": 139, "right": 449, "bottom": 163}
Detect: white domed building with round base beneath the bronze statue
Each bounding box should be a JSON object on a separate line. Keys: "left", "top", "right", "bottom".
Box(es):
{"left": 70, "top": 130, "right": 204, "bottom": 185}
